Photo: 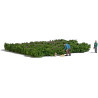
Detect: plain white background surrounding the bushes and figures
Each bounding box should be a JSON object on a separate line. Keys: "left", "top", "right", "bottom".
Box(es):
{"left": 0, "top": 0, "right": 98, "bottom": 98}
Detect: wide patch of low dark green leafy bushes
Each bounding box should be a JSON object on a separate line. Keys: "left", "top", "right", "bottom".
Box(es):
{"left": 4, "top": 39, "right": 91, "bottom": 57}
